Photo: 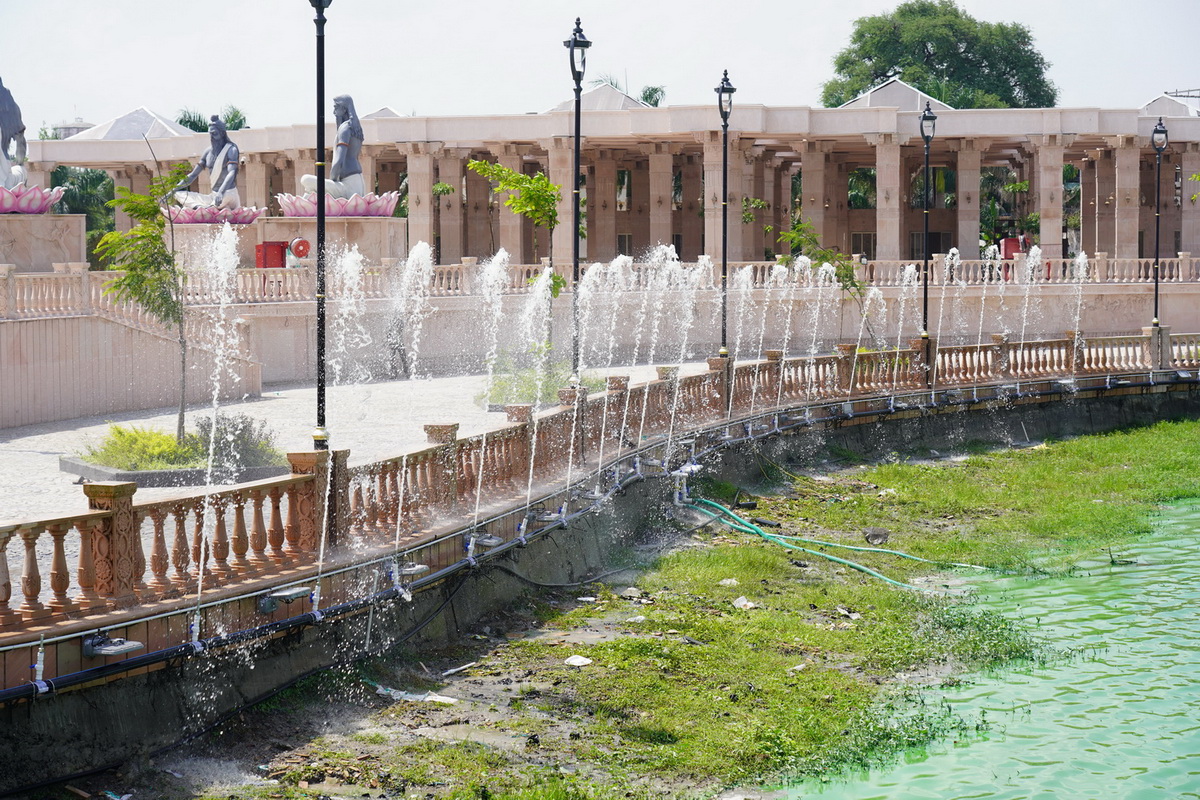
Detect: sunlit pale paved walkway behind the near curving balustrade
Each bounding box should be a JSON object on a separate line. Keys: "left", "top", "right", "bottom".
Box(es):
{"left": 0, "top": 363, "right": 704, "bottom": 522}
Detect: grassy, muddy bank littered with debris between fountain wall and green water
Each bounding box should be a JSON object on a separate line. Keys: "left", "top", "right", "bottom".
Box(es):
{"left": 37, "top": 422, "right": 1200, "bottom": 798}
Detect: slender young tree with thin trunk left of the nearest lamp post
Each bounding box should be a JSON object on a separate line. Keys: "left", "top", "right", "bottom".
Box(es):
{"left": 96, "top": 164, "right": 188, "bottom": 444}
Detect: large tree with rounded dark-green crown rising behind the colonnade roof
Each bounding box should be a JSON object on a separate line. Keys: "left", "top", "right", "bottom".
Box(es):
{"left": 821, "top": 0, "right": 1057, "bottom": 108}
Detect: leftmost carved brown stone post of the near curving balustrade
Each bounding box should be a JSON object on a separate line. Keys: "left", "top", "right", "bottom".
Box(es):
{"left": 83, "top": 481, "right": 142, "bottom": 608}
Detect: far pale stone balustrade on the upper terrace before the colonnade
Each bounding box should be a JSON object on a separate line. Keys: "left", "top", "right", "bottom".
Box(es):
{"left": 9, "top": 253, "right": 1200, "bottom": 325}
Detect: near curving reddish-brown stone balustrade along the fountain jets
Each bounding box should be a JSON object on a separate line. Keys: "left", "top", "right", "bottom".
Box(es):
{"left": 0, "top": 327, "right": 1200, "bottom": 642}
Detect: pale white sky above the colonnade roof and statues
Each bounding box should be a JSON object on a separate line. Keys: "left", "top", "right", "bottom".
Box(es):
{"left": 0, "top": 0, "right": 1200, "bottom": 138}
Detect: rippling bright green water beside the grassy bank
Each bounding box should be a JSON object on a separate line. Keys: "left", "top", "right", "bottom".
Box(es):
{"left": 778, "top": 501, "right": 1200, "bottom": 800}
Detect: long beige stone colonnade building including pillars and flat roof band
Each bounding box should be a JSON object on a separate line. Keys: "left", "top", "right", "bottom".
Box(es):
{"left": 21, "top": 82, "right": 1200, "bottom": 264}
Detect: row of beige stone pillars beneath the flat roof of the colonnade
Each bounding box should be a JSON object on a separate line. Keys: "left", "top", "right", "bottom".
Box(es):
{"left": 21, "top": 131, "right": 1200, "bottom": 264}
